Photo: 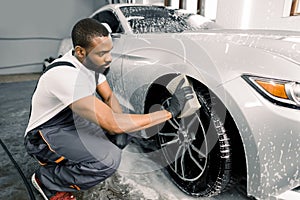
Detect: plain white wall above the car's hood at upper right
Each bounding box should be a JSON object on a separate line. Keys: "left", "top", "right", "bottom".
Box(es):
{"left": 216, "top": 0, "right": 300, "bottom": 31}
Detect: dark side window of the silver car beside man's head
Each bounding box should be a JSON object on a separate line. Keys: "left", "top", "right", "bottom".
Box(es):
{"left": 92, "top": 10, "right": 124, "bottom": 33}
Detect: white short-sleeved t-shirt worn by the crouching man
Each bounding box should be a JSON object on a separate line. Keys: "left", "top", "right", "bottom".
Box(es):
{"left": 25, "top": 50, "right": 106, "bottom": 135}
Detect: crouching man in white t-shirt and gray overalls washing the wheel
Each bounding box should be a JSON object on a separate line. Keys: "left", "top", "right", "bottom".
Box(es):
{"left": 25, "top": 18, "right": 192, "bottom": 200}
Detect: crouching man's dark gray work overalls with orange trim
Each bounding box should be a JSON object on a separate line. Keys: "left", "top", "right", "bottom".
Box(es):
{"left": 25, "top": 62, "right": 121, "bottom": 192}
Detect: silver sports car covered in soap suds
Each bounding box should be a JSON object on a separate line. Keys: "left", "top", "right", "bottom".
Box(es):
{"left": 57, "top": 4, "right": 300, "bottom": 199}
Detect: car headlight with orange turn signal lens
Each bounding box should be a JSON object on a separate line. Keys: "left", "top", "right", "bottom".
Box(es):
{"left": 242, "top": 75, "right": 300, "bottom": 109}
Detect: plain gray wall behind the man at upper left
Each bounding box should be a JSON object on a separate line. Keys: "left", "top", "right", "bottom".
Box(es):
{"left": 0, "top": 0, "right": 106, "bottom": 74}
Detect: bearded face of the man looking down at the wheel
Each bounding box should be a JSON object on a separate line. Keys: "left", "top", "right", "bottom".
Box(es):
{"left": 83, "top": 36, "right": 113, "bottom": 73}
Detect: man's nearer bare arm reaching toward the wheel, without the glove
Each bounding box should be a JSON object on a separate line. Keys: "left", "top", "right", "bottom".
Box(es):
{"left": 70, "top": 95, "right": 172, "bottom": 134}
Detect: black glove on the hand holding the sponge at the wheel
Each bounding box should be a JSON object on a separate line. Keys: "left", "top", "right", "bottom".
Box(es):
{"left": 166, "top": 79, "right": 193, "bottom": 118}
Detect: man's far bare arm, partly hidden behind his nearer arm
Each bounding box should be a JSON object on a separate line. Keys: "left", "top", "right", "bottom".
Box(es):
{"left": 96, "top": 80, "right": 122, "bottom": 113}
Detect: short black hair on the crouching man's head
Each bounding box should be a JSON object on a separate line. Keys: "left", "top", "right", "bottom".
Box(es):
{"left": 72, "top": 18, "right": 109, "bottom": 48}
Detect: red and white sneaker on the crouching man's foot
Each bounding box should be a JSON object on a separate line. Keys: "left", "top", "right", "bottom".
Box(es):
{"left": 31, "top": 173, "right": 76, "bottom": 200}
